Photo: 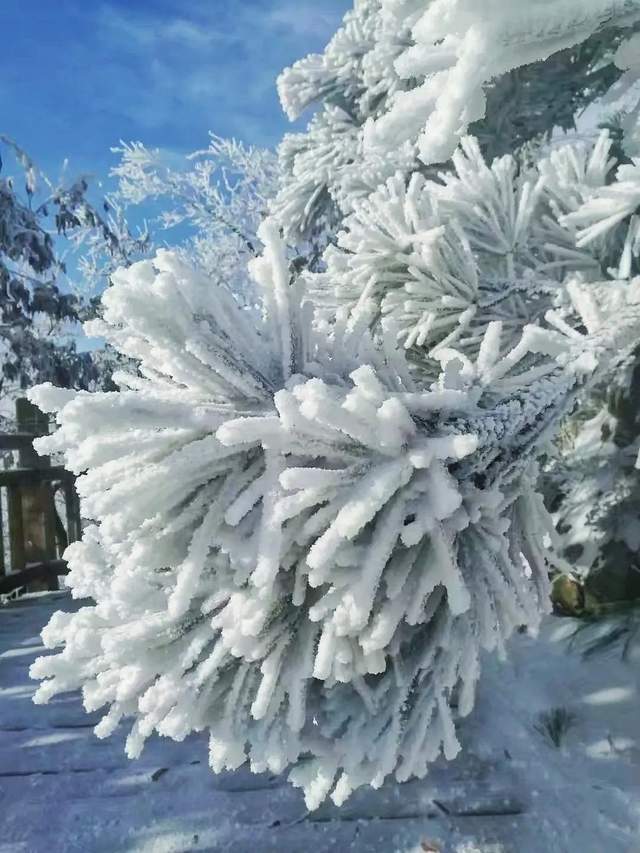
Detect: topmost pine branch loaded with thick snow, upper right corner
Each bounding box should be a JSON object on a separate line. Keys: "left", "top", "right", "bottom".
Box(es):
{"left": 275, "top": 0, "right": 640, "bottom": 237}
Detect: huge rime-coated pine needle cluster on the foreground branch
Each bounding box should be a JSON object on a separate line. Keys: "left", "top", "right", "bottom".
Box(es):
{"left": 31, "top": 215, "right": 640, "bottom": 807}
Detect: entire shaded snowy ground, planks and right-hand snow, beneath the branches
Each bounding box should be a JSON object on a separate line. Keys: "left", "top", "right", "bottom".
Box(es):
{"left": 0, "top": 594, "right": 640, "bottom": 853}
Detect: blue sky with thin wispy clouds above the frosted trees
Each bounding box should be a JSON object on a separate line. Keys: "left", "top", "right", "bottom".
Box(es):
{"left": 0, "top": 0, "right": 351, "bottom": 177}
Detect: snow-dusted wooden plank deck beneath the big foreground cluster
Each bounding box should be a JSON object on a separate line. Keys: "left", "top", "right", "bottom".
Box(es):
{"left": 0, "top": 593, "right": 627, "bottom": 853}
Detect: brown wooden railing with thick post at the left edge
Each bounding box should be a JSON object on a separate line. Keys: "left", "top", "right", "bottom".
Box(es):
{"left": 0, "top": 399, "right": 81, "bottom": 594}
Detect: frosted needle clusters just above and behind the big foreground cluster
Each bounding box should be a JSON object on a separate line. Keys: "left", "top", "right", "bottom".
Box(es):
{"left": 305, "top": 131, "right": 624, "bottom": 372}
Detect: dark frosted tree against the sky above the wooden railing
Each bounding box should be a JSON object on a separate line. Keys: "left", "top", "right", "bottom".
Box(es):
{"left": 0, "top": 137, "right": 115, "bottom": 396}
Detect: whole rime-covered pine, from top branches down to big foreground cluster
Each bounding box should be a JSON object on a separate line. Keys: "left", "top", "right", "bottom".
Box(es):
{"left": 27, "top": 0, "right": 640, "bottom": 808}
